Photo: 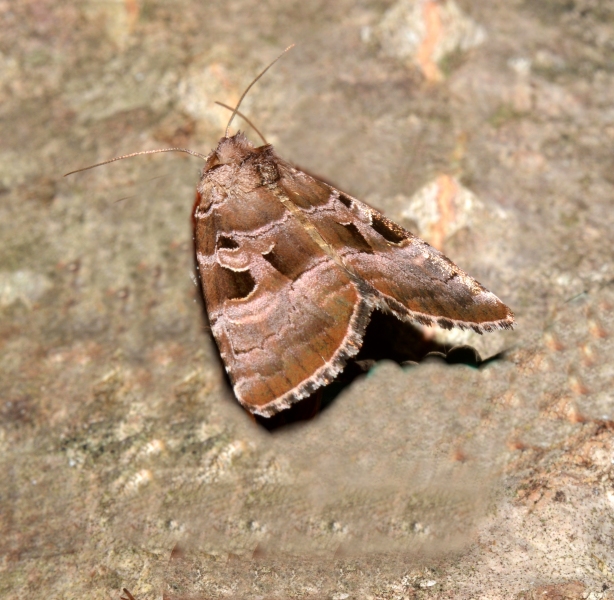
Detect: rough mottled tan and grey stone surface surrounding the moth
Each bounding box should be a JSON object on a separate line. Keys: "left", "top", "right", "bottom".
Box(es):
{"left": 0, "top": 0, "right": 614, "bottom": 600}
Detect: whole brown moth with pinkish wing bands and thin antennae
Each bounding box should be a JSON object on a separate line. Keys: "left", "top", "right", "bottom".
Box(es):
{"left": 67, "top": 49, "right": 514, "bottom": 417}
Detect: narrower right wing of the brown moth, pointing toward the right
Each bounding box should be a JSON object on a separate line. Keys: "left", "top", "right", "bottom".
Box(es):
{"left": 279, "top": 157, "right": 514, "bottom": 332}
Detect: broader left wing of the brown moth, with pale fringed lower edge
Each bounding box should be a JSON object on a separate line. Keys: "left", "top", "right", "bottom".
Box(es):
{"left": 194, "top": 167, "right": 372, "bottom": 416}
